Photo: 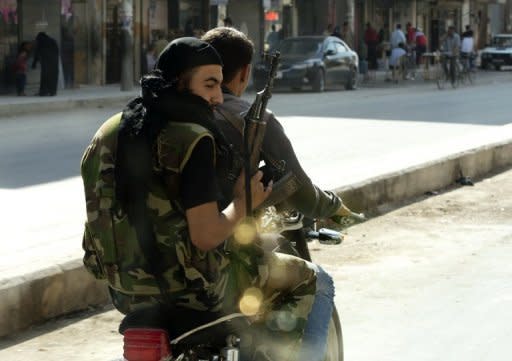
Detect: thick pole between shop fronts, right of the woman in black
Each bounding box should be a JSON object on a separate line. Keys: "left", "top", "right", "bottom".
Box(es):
{"left": 119, "top": 0, "right": 134, "bottom": 91}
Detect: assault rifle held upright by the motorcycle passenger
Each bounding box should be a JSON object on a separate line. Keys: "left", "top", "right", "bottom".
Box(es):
{"left": 243, "top": 52, "right": 281, "bottom": 217}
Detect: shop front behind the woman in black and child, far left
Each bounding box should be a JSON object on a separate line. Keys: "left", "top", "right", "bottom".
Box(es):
{"left": 0, "top": 0, "right": 95, "bottom": 93}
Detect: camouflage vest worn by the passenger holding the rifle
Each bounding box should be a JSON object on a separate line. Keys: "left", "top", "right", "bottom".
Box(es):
{"left": 81, "top": 114, "right": 228, "bottom": 309}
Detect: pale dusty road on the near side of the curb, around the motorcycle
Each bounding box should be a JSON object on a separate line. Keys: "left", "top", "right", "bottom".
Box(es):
{"left": 0, "top": 170, "right": 512, "bottom": 361}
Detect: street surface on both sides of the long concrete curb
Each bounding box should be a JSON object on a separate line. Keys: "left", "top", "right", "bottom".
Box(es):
{"left": 0, "top": 72, "right": 512, "bottom": 361}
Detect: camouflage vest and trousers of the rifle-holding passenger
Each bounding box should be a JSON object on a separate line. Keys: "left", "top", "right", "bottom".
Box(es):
{"left": 81, "top": 97, "right": 316, "bottom": 360}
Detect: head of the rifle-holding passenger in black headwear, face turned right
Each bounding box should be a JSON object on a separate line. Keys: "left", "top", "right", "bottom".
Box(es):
{"left": 156, "top": 38, "right": 222, "bottom": 105}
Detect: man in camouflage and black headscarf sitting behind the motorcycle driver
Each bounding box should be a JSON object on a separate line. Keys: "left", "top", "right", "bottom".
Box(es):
{"left": 81, "top": 38, "right": 316, "bottom": 361}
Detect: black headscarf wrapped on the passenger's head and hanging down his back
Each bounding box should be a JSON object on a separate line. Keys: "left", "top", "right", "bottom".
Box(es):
{"left": 115, "top": 37, "right": 230, "bottom": 215}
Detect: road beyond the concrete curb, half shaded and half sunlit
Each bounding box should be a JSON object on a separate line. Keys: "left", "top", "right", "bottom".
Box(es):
{"left": 0, "top": 73, "right": 511, "bottom": 280}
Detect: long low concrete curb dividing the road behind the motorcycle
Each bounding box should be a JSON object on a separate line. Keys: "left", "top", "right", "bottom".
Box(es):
{"left": 0, "top": 132, "right": 512, "bottom": 337}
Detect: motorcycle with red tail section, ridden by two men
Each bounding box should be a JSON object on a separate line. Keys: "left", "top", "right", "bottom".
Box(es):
{"left": 115, "top": 207, "right": 364, "bottom": 361}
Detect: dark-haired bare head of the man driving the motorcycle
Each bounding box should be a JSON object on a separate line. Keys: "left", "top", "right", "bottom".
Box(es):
{"left": 202, "top": 27, "right": 254, "bottom": 95}
